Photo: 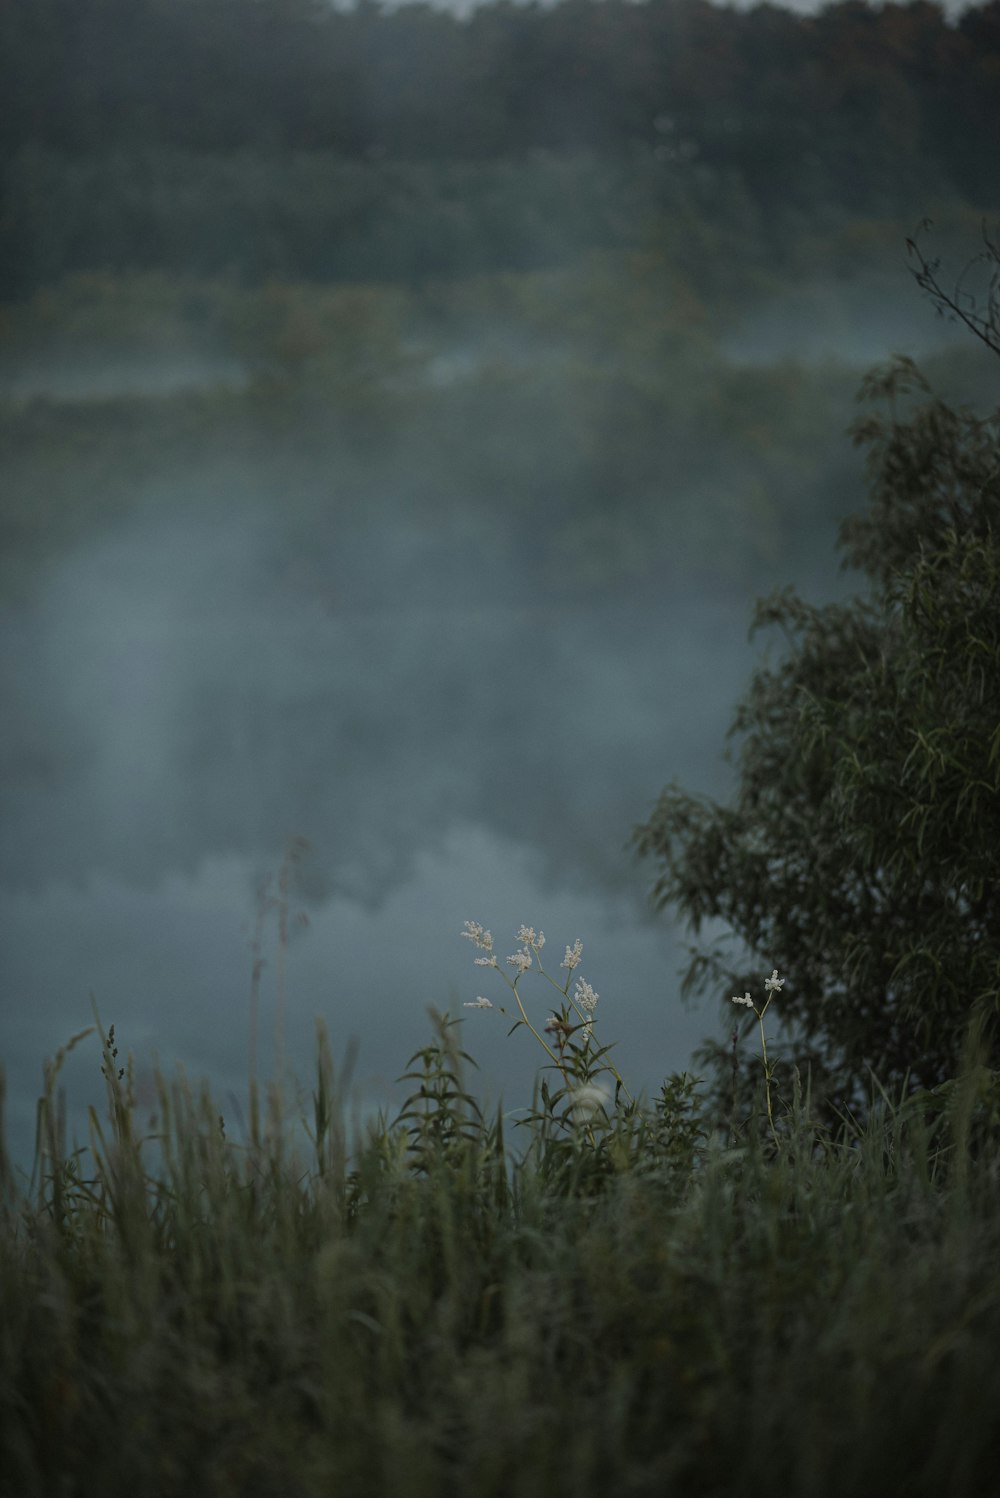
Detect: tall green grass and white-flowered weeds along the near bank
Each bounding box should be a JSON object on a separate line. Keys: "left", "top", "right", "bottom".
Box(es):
{"left": 0, "top": 924, "right": 1000, "bottom": 1498}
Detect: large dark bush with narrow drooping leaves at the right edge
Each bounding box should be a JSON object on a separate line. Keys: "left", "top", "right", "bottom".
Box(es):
{"left": 636, "top": 347, "right": 1000, "bottom": 1098}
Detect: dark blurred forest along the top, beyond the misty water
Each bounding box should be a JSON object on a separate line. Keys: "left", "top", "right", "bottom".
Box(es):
{"left": 0, "top": 0, "right": 1000, "bottom": 300}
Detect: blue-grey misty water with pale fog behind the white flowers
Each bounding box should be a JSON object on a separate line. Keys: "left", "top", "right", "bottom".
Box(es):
{"left": 0, "top": 272, "right": 982, "bottom": 1165}
